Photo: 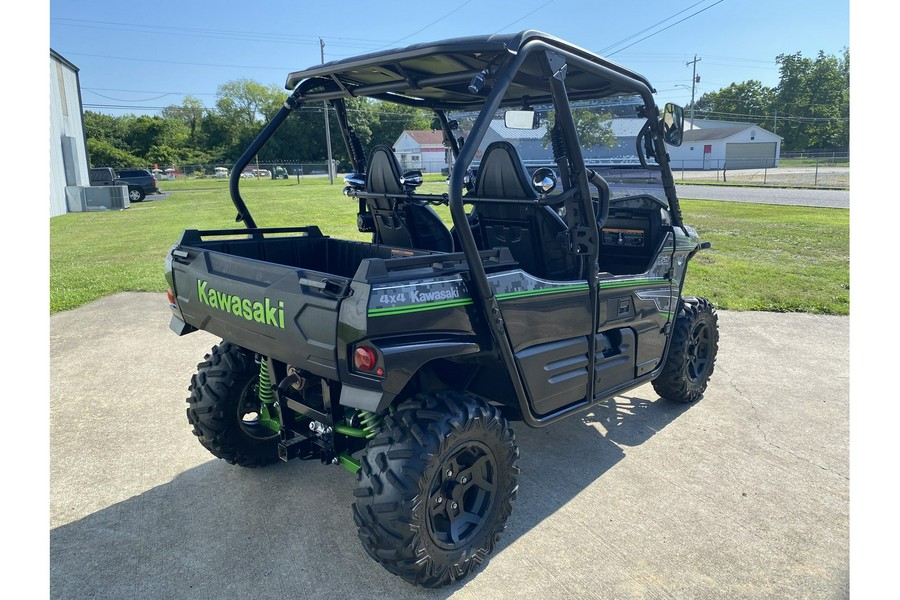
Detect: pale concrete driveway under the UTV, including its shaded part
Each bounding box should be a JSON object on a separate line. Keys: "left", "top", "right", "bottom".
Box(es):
{"left": 50, "top": 293, "right": 849, "bottom": 600}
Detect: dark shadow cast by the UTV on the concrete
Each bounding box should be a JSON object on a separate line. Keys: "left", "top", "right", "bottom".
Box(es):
{"left": 50, "top": 386, "right": 687, "bottom": 600}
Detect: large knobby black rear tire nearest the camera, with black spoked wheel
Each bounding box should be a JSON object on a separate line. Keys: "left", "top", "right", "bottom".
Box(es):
{"left": 353, "top": 392, "right": 519, "bottom": 587}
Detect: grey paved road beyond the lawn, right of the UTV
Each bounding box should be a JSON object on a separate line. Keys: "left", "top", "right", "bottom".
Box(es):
{"left": 675, "top": 185, "right": 850, "bottom": 208}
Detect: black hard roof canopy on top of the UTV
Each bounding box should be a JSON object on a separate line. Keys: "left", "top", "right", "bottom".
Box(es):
{"left": 285, "top": 31, "right": 655, "bottom": 110}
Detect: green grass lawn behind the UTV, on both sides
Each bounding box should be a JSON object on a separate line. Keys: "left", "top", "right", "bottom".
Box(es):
{"left": 50, "top": 177, "right": 850, "bottom": 315}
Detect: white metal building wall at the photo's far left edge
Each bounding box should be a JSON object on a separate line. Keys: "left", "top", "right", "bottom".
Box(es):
{"left": 50, "top": 48, "right": 90, "bottom": 217}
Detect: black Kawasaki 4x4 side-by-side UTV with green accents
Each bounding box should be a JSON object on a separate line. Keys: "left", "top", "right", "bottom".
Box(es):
{"left": 166, "top": 31, "right": 718, "bottom": 587}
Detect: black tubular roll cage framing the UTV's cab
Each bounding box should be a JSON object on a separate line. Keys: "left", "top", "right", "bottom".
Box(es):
{"left": 229, "top": 32, "right": 682, "bottom": 427}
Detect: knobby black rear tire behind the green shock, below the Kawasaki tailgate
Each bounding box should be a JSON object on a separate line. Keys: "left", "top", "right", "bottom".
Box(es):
{"left": 187, "top": 342, "right": 278, "bottom": 467}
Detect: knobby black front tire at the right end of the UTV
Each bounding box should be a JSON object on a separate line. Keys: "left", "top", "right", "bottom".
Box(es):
{"left": 653, "top": 296, "right": 719, "bottom": 402}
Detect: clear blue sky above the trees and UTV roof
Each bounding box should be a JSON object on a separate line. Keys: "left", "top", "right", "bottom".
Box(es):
{"left": 47, "top": 0, "right": 850, "bottom": 114}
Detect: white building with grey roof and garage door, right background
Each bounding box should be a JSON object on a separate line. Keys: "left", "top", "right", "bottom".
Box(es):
{"left": 668, "top": 119, "right": 781, "bottom": 170}
